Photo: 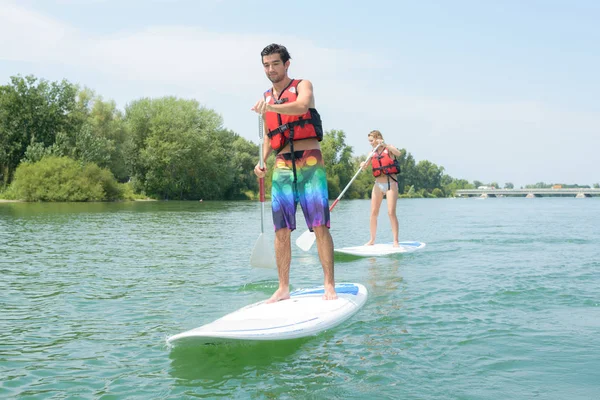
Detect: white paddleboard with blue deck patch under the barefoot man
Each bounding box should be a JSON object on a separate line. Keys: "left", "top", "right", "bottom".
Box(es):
{"left": 167, "top": 283, "right": 368, "bottom": 344}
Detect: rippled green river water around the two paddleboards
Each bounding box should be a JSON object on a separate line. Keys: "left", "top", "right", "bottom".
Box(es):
{"left": 0, "top": 198, "right": 600, "bottom": 399}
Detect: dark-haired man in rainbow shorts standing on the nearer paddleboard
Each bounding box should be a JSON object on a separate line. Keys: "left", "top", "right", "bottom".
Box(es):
{"left": 252, "top": 44, "right": 337, "bottom": 303}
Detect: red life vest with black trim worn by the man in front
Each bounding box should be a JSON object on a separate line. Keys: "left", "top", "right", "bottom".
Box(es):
{"left": 264, "top": 79, "right": 323, "bottom": 150}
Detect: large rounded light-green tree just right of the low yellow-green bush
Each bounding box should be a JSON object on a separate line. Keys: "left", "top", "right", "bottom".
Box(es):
{"left": 132, "top": 97, "right": 225, "bottom": 200}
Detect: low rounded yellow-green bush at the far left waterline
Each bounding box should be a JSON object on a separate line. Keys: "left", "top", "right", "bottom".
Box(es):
{"left": 9, "top": 156, "right": 125, "bottom": 201}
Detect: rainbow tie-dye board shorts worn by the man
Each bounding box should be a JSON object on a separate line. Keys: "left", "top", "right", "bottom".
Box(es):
{"left": 271, "top": 150, "right": 329, "bottom": 231}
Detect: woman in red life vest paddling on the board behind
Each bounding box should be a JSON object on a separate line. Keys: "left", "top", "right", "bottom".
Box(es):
{"left": 361, "top": 131, "right": 402, "bottom": 247}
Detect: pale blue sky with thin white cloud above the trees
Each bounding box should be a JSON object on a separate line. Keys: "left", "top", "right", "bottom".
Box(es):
{"left": 0, "top": 0, "right": 600, "bottom": 187}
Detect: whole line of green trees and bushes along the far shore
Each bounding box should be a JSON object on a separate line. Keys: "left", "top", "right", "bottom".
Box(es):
{"left": 0, "top": 75, "right": 598, "bottom": 201}
